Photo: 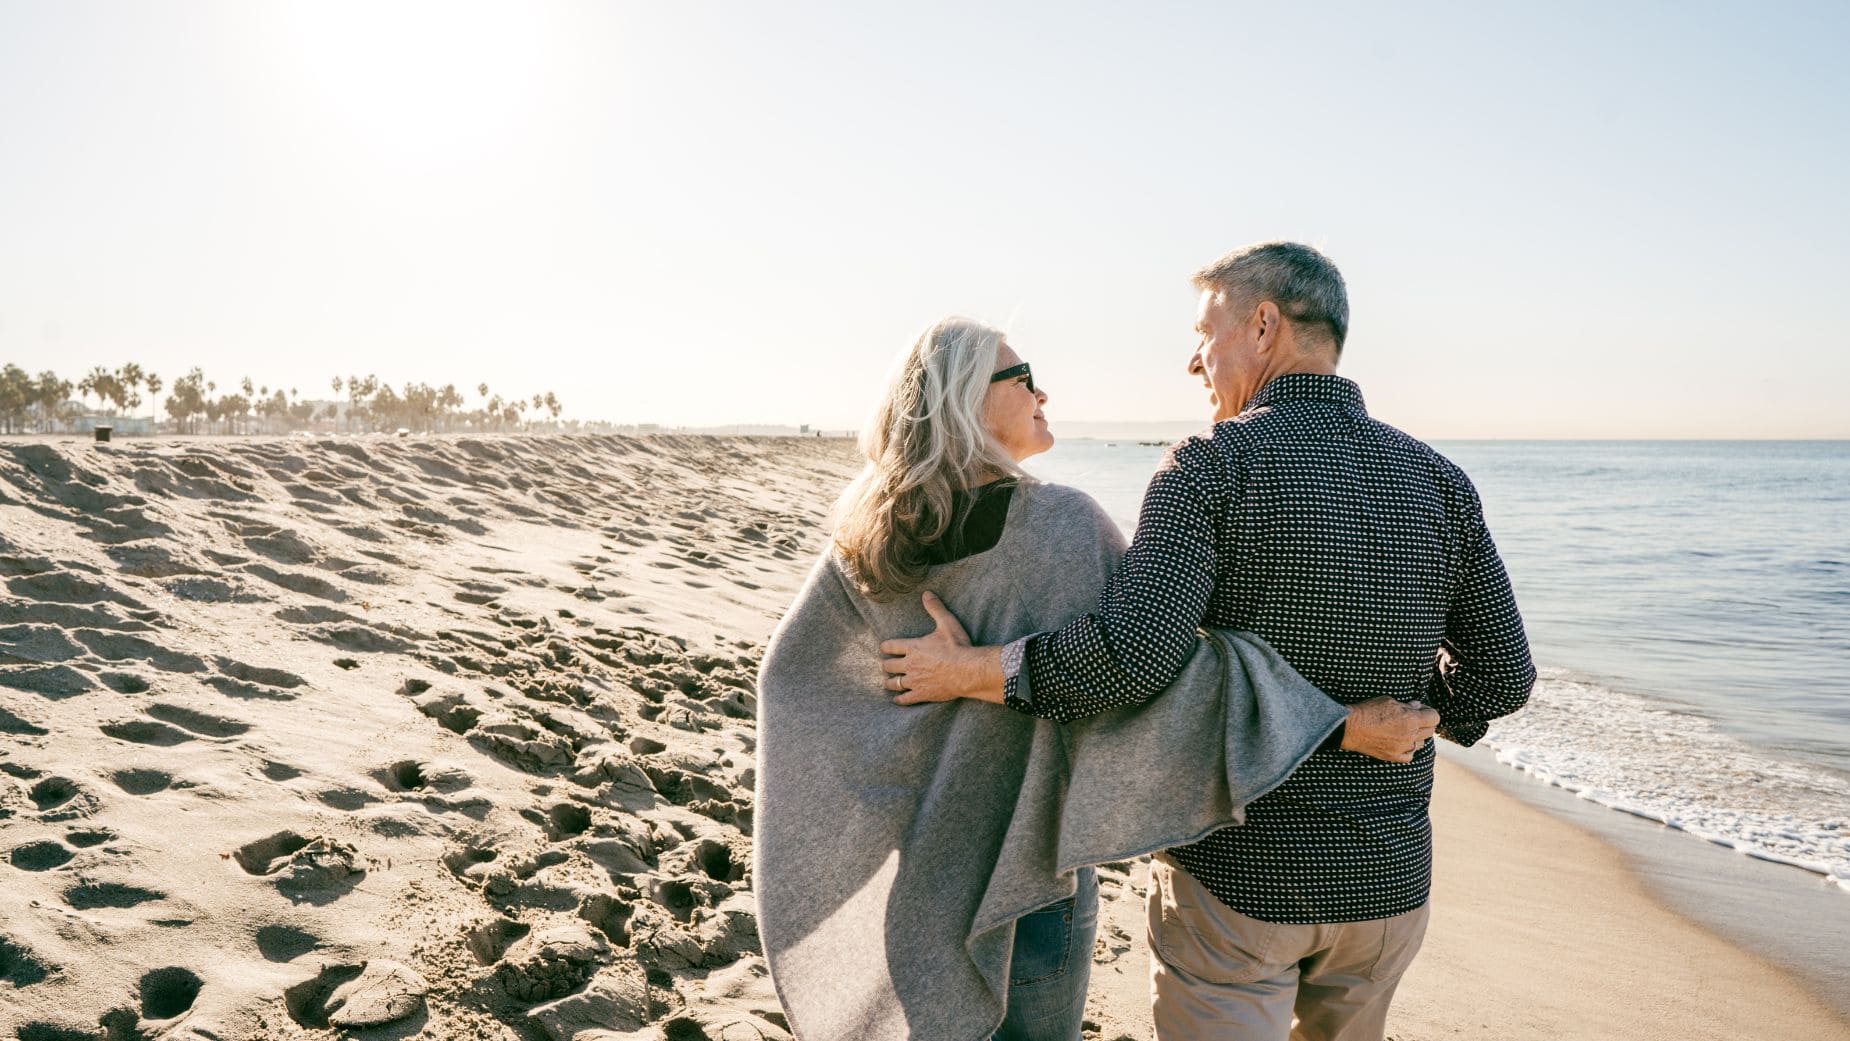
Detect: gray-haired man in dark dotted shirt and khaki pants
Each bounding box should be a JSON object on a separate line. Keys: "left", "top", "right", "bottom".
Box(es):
{"left": 882, "top": 242, "right": 1536, "bottom": 1041}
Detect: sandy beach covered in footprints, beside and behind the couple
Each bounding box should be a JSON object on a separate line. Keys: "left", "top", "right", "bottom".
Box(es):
{"left": 0, "top": 436, "right": 1850, "bottom": 1041}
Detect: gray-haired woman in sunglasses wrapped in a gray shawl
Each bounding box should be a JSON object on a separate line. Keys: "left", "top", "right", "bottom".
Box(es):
{"left": 753, "top": 318, "right": 1345, "bottom": 1041}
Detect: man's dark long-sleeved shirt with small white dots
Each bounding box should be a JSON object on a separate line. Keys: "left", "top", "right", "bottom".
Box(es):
{"left": 1006, "top": 374, "right": 1536, "bottom": 923}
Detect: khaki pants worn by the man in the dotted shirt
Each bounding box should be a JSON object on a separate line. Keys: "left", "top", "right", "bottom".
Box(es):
{"left": 1149, "top": 856, "right": 1426, "bottom": 1041}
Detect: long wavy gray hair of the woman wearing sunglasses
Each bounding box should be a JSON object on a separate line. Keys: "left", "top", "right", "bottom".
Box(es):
{"left": 834, "top": 316, "right": 1021, "bottom": 599}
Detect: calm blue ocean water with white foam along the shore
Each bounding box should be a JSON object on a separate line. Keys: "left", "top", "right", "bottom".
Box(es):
{"left": 1027, "top": 440, "right": 1850, "bottom": 891}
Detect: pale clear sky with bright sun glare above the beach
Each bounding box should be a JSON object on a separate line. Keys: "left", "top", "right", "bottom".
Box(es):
{"left": 0, "top": 0, "right": 1850, "bottom": 438}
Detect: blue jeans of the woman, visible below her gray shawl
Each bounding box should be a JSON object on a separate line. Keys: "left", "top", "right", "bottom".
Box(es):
{"left": 993, "top": 867, "right": 1099, "bottom": 1041}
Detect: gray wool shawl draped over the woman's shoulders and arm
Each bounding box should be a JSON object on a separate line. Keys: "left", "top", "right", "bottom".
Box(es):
{"left": 753, "top": 483, "right": 1347, "bottom": 1041}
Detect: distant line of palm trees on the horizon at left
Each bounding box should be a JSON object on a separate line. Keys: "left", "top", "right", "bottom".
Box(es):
{"left": 0, "top": 362, "right": 562, "bottom": 435}
